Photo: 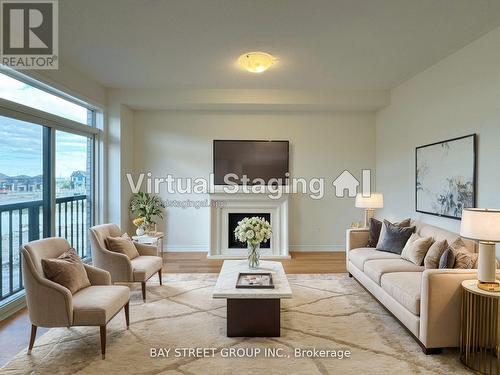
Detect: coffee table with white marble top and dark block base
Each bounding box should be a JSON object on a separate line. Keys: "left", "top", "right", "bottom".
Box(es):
{"left": 212, "top": 260, "right": 292, "bottom": 337}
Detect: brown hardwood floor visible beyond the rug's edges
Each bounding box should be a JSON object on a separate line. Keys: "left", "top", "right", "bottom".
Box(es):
{"left": 0, "top": 252, "right": 346, "bottom": 367}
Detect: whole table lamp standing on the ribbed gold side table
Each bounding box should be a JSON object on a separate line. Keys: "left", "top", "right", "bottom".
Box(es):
{"left": 460, "top": 208, "right": 500, "bottom": 292}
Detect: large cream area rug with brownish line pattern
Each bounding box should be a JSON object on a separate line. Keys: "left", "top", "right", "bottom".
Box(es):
{"left": 0, "top": 274, "right": 468, "bottom": 375}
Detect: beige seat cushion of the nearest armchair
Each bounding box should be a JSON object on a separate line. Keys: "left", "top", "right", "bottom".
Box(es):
{"left": 73, "top": 285, "right": 130, "bottom": 326}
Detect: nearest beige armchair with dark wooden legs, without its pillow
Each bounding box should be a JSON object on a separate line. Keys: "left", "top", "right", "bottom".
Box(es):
{"left": 21, "top": 238, "right": 130, "bottom": 359}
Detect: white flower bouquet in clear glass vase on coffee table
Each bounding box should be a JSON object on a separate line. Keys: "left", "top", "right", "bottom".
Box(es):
{"left": 234, "top": 216, "right": 273, "bottom": 268}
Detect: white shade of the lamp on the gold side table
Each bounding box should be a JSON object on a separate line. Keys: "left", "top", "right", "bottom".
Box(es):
{"left": 460, "top": 208, "right": 500, "bottom": 242}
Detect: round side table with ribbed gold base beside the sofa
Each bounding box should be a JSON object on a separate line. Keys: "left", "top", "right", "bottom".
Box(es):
{"left": 460, "top": 280, "right": 500, "bottom": 375}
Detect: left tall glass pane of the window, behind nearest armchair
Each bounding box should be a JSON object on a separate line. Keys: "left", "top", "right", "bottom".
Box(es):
{"left": 0, "top": 116, "right": 44, "bottom": 298}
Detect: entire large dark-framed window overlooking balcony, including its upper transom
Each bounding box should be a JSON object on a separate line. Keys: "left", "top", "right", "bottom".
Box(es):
{"left": 0, "top": 73, "right": 100, "bottom": 306}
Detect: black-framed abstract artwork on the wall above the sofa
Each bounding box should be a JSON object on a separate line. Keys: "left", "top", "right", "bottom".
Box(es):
{"left": 415, "top": 134, "right": 476, "bottom": 220}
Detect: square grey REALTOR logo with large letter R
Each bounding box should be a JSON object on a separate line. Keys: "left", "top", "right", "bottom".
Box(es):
{"left": 0, "top": 0, "right": 59, "bottom": 69}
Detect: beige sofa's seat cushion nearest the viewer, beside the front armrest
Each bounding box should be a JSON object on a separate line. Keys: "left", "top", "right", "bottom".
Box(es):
{"left": 380, "top": 272, "right": 422, "bottom": 316}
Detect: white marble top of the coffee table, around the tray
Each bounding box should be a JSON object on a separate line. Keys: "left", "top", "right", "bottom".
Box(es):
{"left": 212, "top": 259, "right": 292, "bottom": 298}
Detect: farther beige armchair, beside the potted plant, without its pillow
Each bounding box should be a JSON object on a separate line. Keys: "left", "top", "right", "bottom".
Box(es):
{"left": 89, "top": 224, "right": 163, "bottom": 302}
